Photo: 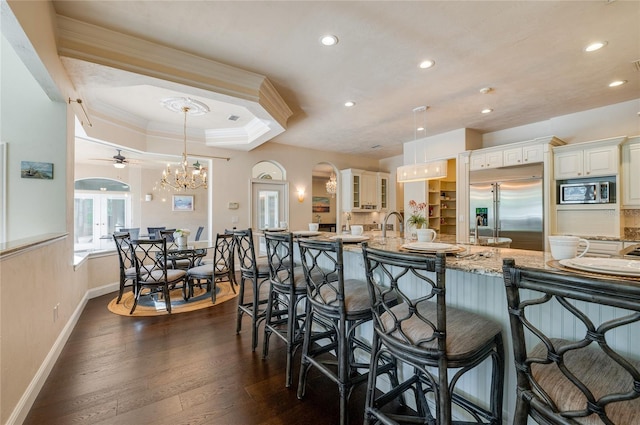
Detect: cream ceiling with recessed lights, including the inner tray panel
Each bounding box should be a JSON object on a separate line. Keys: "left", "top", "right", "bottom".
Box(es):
{"left": 53, "top": 1, "right": 640, "bottom": 164}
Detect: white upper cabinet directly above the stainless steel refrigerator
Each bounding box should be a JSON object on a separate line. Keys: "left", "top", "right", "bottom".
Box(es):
{"left": 469, "top": 137, "right": 564, "bottom": 171}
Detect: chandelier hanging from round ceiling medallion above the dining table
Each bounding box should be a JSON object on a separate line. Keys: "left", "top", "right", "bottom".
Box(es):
{"left": 160, "top": 98, "right": 209, "bottom": 192}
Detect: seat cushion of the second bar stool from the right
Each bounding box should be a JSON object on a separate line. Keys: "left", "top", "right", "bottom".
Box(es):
{"left": 380, "top": 302, "right": 502, "bottom": 358}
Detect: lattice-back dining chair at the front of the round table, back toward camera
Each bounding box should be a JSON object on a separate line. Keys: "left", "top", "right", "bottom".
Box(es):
{"left": 129, "top": 239, "right": 187, "bottom": 314}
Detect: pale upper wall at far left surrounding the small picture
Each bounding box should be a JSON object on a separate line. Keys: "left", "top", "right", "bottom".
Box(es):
{"left": 0, "top": 36, "right": 67, "bottom": 240}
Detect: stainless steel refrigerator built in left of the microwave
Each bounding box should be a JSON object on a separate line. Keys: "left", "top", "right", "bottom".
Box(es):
{"left": 469, "top": 164, "right": 544, "bottom": 251}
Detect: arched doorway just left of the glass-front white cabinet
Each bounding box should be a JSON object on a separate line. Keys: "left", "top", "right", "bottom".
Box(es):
{"left": 311, "top": 162, "right": 340, "bottom": 232}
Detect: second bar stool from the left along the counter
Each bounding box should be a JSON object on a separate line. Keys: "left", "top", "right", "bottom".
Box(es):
{"left": 262, "top": 232, "right": 307, "bottom": 387}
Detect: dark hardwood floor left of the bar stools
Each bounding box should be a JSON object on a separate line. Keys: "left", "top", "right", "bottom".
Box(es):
{"left": 24, "top": 286, "right": 366, "bottom": 425}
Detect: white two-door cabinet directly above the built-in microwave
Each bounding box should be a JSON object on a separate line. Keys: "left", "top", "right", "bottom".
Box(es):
{"left": 554, "top": 139, "right": 620, "bottom": 180}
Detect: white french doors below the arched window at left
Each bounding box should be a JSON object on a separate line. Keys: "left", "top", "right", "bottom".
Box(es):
{"left": 74, "top": 192, "right": 130, "bottom": 251}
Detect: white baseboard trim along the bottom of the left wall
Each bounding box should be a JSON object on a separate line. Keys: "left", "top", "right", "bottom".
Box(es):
{"left": 5, "top": 282, "right": 119, "bottom": 425}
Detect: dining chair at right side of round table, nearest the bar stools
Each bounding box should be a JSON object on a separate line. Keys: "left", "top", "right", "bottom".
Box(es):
{"left": 187, "top": 233, "right": 236, "bottom": 303}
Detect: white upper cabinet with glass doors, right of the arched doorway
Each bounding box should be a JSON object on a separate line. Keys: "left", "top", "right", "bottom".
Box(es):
{"left": 340, "top": 168, "right": 389, "bottom": 212}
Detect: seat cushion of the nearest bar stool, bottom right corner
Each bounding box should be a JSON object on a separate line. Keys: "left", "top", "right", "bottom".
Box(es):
{"left": 528, "top": 339, "right": 640, "bottom": 425}
